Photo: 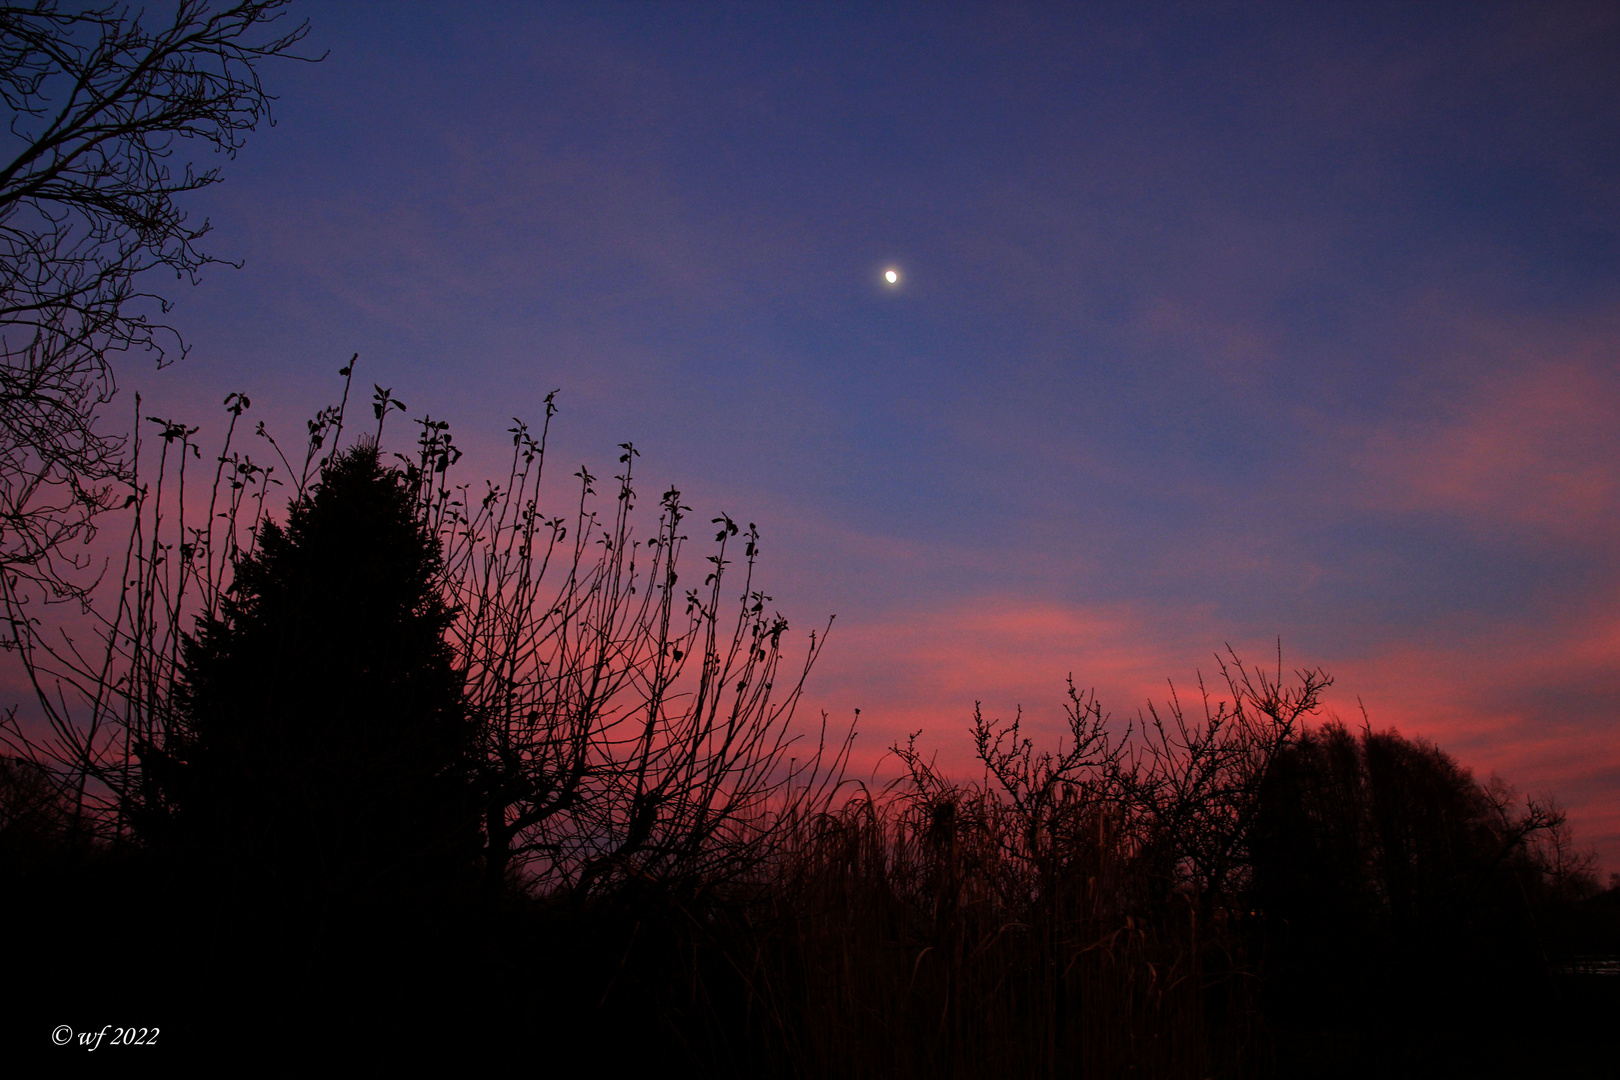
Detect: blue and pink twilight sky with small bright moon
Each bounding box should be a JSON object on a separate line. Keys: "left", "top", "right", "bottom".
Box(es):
{"left": 123, "top": 3, "right": 1620, "bottom": 870}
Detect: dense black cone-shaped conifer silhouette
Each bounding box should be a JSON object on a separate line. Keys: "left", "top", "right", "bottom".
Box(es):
{"left": 139, "top": 442, "right": 480, "bottom": 905}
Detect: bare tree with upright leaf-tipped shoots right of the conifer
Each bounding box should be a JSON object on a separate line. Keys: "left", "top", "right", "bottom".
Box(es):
{"left": 408, "top": 408, "right": 854, "bottom": 902}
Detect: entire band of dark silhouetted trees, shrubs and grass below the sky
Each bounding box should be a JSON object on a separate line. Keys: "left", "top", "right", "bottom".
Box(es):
{"left": 0, "top": 368, "right": 1620, "bottom": 1077}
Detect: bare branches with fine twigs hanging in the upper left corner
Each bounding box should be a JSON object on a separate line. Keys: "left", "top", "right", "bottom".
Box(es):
{"left": 0, "top": 0, "right": 308, "bottom": 596}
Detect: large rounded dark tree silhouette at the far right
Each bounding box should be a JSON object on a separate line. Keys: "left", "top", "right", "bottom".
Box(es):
{"left": 1251, "top": 722, "right": 1589, "bottom": 1069}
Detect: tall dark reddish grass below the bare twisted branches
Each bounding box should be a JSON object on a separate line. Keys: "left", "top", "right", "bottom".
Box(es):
{"left": 757, "top": 789, "right": 1257, "bottom": 1077}
